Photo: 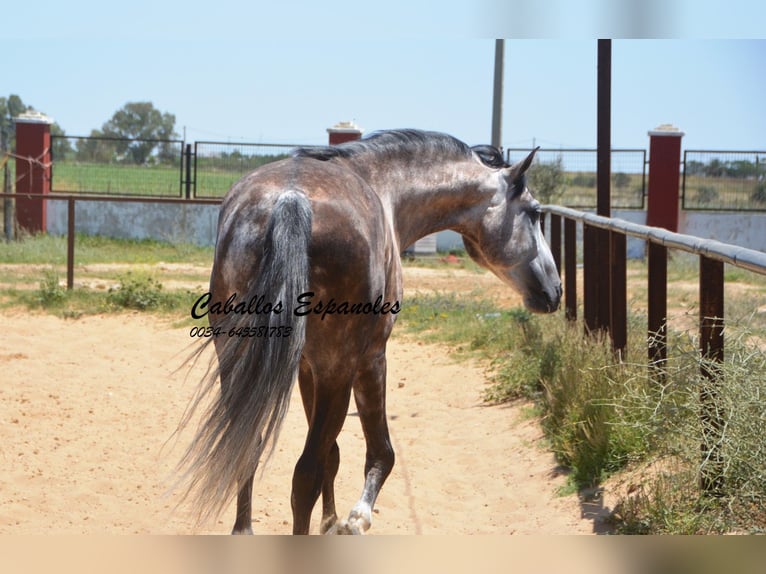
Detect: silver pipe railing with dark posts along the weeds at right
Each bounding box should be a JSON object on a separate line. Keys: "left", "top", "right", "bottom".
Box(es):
{"left": 543, "top": 205, "right": 766, "bottom": 492}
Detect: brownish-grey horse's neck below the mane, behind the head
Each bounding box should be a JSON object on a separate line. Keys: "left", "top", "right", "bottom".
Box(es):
{"left": 356, "top": 163, "right": 487, "bottom": 249}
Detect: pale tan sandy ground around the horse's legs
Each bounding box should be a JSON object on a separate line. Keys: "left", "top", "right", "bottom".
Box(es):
{"left": 0, "top": 269, "right": 608, "bottom": 534}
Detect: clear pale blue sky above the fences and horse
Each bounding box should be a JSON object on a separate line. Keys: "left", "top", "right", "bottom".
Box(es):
{"left": 0, "top": 0, "right": 766, "bottom": 150}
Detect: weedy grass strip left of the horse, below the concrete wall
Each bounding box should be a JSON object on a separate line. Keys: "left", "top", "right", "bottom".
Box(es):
{"left": 0, "top": 235, "right": 213, "bottom": 324}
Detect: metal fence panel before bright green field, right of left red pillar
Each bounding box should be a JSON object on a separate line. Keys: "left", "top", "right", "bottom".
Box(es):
{"left": 51, "top": 135, "right": 183, "bottom": 197}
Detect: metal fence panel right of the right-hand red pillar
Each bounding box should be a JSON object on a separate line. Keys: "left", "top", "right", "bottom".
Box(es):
{"left": 681, "top": 150, "right": 766, "bottom": 211}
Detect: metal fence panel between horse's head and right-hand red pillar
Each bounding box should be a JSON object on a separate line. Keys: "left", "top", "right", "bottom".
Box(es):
{"left": 506, "top": 148, "right": 646, "bottom": 209}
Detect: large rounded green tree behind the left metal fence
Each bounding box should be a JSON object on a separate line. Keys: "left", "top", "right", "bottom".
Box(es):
{"left": 101, "top": 102, "right": 178, "bottom": 165}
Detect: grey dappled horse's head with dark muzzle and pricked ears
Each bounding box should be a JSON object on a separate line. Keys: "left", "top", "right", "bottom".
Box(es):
{"left": 463, "top": 149, "right": 561, "bottom": 313}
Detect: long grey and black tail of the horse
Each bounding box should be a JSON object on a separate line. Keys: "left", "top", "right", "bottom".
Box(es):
{"left": 180, "top": 190, "right": 312, "bottom": 521}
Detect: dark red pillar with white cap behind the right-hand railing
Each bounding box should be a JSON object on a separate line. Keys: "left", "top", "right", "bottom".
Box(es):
{"left": 646, "top": 124, "right": 684, "bottom": 231}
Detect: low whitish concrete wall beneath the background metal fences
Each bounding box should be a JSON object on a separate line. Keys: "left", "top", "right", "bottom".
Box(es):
{"left": 47, "top": 201, "right": 766, "bottom": 258}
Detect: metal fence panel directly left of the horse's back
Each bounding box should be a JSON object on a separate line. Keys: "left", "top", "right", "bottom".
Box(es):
{"left": 193, "top": 141, "right": 312, "bottom": 198}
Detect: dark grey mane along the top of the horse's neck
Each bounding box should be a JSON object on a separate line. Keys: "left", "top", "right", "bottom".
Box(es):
{"left": 293, "top": 129, "right": 508, "bottom": 168}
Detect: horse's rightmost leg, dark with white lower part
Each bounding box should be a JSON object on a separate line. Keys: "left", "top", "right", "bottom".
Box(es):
{"left": 336, "top": 354, "right": 394, "bottom": 534}
